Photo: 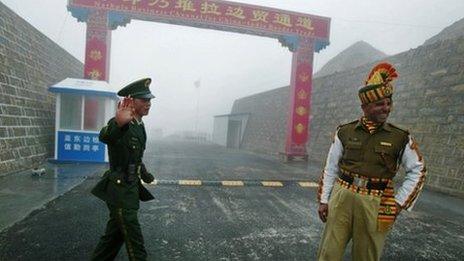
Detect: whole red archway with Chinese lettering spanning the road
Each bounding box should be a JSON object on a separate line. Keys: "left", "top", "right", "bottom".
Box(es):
{"left": 68, "top": 0, "right": 330, "bottom": 158}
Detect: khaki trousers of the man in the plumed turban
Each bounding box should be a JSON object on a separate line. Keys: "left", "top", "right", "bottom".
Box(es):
{"left": 317, "top": 182, "right": 388, "bottom": 261}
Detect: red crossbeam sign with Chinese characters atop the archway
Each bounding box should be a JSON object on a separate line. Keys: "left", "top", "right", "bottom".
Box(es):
{"left": 69, "top": 0, "right": 330, "bottom": 40}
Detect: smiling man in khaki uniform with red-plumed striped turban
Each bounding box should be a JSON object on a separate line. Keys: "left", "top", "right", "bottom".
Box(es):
{"left": 318, "top": 63, "right": 426, "bottom": 261}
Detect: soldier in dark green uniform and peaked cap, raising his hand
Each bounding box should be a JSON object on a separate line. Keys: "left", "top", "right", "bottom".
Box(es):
{"left": 92, "top": 78, "right": 155, "bottom": 260}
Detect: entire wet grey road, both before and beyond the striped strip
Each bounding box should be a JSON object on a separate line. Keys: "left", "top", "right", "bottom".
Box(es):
{"left": 0, "top": 143, "right": 464, "bottom": 261}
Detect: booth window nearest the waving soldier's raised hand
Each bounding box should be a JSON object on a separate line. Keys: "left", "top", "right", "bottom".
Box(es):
{"left": 84, "top": 96, "right": 105, "bottom": 130}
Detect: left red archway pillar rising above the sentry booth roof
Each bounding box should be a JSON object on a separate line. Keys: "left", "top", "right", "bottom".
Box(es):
{"left": 84, "top": 10, "right": 111, "bottom": 81}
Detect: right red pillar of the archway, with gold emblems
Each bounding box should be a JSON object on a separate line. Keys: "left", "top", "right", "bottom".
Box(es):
{"left": 285, "top": 38, "right": 314, "bottom": 159}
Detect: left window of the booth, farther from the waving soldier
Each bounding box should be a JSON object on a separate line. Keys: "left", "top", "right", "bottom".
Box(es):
{"left": 60, "top": 93, "right": 82, "bottom": 130}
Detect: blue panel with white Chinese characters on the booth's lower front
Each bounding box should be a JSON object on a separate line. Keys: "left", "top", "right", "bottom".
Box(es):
{"left": 57, "top": 131, "right": 105, "bottom": 162}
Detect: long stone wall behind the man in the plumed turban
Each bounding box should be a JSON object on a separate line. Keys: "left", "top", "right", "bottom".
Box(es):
{"left": 232, "top": 37, "right": 464, "bottom": 197}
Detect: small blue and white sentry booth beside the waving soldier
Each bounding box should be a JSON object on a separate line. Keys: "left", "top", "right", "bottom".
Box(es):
{"left": 48, "top": 78, "right": 118, "bottom": 163}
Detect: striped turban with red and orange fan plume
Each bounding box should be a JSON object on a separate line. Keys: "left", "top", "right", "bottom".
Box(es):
{"left": 358, "top": 62, "right": 398, "bottom": 104}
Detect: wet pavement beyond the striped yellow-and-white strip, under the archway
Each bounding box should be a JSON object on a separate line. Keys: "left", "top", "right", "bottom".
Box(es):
{"left": 144, "top": 142, "right": 320, "bottom": 181}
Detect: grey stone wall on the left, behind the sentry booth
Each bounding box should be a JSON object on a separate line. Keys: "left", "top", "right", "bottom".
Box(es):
{"left": 0, "top": 2, "right": 83, "bottom": 176}
